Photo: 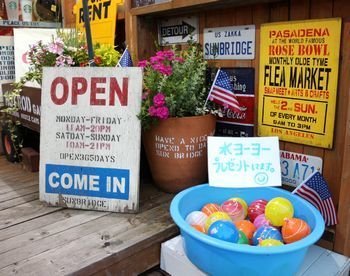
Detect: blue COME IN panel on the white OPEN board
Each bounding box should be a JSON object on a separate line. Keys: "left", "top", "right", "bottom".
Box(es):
{"left": 45, "top": 164, "right": 130, "bottom": 200}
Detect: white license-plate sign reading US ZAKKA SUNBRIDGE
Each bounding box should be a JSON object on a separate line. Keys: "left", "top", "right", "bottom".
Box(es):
{"left": 203, "top": 25, "right": 255, "bottom": 59}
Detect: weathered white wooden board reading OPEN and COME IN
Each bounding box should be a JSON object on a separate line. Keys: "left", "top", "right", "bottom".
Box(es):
{"left": 40, "top": 67, "right": 142, "bottom": 212}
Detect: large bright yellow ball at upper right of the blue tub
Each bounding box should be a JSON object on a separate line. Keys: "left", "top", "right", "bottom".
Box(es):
{"left": 265, "top": 197, "right": 294, "bottom": 226}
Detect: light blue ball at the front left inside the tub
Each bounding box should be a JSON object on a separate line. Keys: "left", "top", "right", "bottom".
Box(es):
{"left": 208, "top": 220, "right": 239, "bottom": 243}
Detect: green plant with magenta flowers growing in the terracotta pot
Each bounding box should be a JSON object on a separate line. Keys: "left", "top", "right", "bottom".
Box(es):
{"left": 138, "top": 43, "right": 215, "bottom": 129}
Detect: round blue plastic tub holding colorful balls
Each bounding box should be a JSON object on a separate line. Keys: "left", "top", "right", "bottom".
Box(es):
{"left": 170, "top": 184, "right": 324, "bottom": 276}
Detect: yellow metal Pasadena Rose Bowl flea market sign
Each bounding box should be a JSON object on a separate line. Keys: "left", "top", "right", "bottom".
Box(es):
{"left": 258, "top": 18, "right": 341, "bottom": 148}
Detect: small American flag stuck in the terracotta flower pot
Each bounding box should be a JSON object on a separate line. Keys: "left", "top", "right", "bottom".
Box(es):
{"left": 208, "top": 69, "right": 241, "bottom": 112}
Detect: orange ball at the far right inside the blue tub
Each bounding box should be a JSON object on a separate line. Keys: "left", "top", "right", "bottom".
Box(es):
{"left": 282, "top": 218, "right": 311, "bottom": 243}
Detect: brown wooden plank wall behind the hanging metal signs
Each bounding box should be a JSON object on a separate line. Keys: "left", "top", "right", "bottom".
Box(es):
{"left": 126, "top": 0, "right": 350, "bottom": 256}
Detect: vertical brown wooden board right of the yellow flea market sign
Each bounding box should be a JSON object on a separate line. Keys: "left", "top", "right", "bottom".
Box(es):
{"left": 333, "top": 0, "right": 350, "bottom": 257}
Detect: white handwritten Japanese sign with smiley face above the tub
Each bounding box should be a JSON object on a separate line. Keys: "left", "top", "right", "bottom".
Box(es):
{"left": 208, "top": 137, "right": 281, "bottom": 187}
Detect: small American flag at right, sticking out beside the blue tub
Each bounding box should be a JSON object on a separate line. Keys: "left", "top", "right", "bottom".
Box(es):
{"left": 292, "top": 171, "right": 338, "bottom": 226}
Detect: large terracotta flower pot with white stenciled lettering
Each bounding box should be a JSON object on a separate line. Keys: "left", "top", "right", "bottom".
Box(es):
{"left": 142, "top": 114, "right": 216, "bottom": 193}
